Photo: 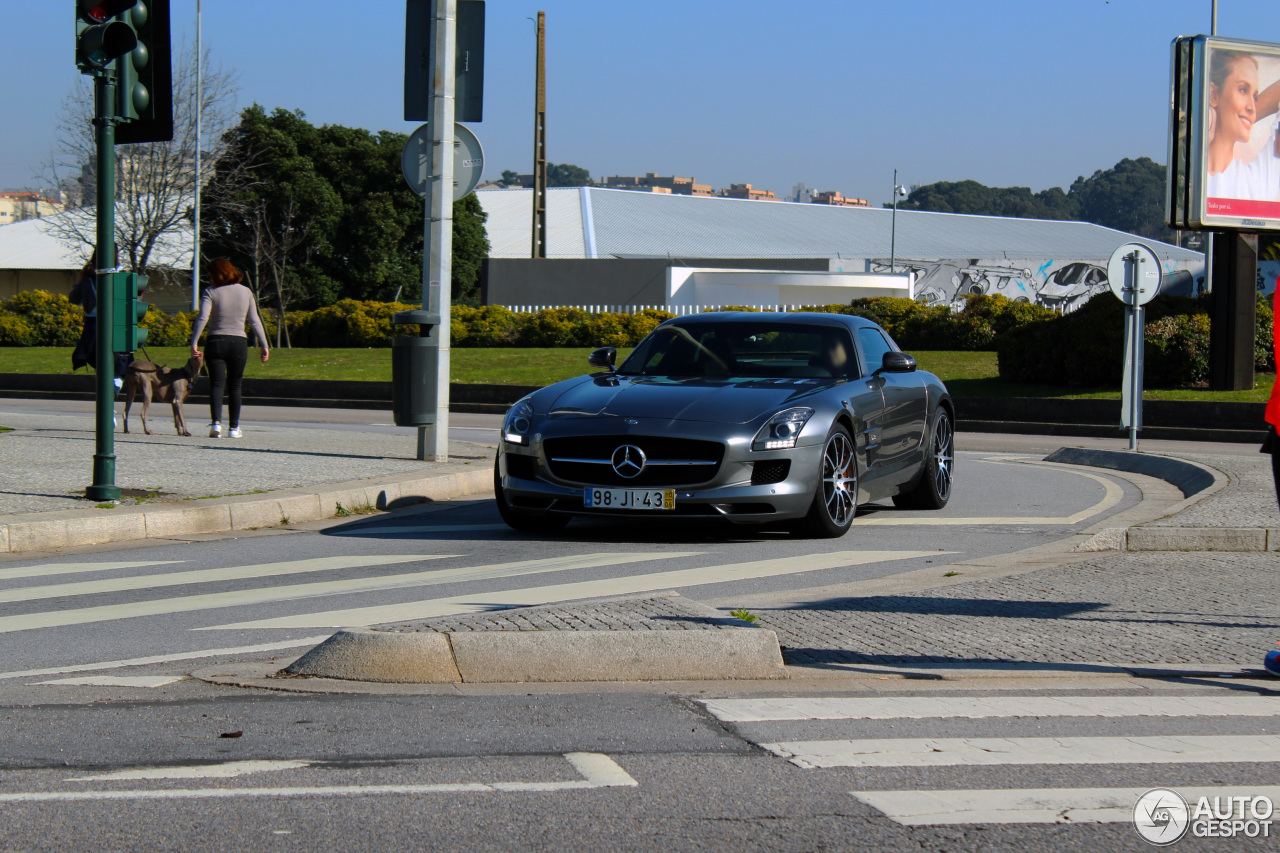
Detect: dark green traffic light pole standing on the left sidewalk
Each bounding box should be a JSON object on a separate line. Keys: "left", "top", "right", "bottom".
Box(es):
{"left": 84, "top": 69, "right": 128, "bottom": 501}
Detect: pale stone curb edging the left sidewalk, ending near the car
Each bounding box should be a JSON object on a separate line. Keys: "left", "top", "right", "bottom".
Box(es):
{"left": 0, "top": 465, "right": 493, "bottom": 553}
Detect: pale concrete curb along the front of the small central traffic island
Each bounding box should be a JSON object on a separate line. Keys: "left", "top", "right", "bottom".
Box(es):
{"left": 279, "top": 628, "right": 786, "bottom": 684}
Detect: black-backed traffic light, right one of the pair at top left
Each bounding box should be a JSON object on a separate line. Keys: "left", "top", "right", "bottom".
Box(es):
{"left": 115, "top": 0, "right": 173, "bottom": 145}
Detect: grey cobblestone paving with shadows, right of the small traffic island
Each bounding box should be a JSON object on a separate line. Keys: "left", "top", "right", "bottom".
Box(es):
{"left": 755, "top": 552, "right": 1280, "bottom": 666}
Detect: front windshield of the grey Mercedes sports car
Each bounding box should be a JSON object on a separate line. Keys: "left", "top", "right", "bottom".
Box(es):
{"left": 618, "top": 320, "right": 855, "bottom": 379}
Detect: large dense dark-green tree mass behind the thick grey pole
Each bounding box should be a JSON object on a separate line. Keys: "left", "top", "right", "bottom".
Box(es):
{"left": 204, "top": 105, "right": 489, "bottom": 310}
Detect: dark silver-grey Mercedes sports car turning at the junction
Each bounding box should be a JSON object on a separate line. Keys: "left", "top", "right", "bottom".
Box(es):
{"left": 494, "top": 311, "right": 955, "bottom": 537}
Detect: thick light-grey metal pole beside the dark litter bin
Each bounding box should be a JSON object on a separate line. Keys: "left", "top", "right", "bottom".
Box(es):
{"left": 417, "top": 0, "right": 457, "bottom": 462}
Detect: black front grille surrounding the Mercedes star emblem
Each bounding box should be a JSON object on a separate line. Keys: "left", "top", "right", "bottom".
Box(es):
{"left": 543, "top": 435, "right": 724, "bottom": 488}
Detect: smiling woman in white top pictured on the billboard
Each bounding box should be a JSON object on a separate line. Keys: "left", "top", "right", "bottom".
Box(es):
{"left": 1206, "top": 49, "right": 1280, "bottom": 201}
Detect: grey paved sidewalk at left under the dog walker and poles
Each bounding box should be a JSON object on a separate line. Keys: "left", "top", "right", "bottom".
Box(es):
{"left": 0, "top": 406, "right": 493, "bottom": 516}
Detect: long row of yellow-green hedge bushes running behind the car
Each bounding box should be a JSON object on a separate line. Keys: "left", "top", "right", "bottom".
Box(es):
{"left": 0, "top": 291, "right": 1275, "bottom": 387}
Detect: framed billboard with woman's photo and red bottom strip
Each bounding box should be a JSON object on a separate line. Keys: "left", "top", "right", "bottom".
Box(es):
{"left": 1165, "top": 36, "right": 1280, "bottom": 232}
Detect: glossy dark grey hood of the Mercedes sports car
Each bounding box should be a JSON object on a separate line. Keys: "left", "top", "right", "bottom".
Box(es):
{"left": 548, "top": 375, "right": 845, "bottom": 424}
